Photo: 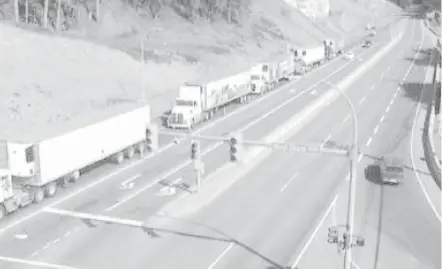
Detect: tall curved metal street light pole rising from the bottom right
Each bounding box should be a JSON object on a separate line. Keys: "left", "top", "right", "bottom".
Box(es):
{"left": 325, "top": 81, "right": 358, "bottom": 269}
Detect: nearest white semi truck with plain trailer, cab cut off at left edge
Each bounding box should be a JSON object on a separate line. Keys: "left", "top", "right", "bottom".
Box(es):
{"left": 0, "top": 103, "right": 150, "bottom": 218}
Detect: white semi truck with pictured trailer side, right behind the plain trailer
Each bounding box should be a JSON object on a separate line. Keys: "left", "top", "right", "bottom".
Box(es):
{"left": 167, "top": 72, "right": 252, "bottom": 129}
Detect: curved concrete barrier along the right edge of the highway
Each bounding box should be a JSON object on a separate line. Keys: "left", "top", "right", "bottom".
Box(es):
{"left": 422, "top": 58, "right": 442, "bottom": 189}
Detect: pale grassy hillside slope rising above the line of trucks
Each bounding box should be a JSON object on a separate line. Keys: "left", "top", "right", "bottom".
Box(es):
{"left": 0, "top": 0, "right": 397, "bottom": 138}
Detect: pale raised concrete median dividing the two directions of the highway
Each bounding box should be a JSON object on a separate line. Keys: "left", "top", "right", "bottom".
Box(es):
{"left": 163, "top": 23, "right": 404, "bottom": 217}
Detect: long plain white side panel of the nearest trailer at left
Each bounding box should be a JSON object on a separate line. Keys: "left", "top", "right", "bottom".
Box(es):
{"left": 31, "top": 106, "right": 150, "bottom": 185}
